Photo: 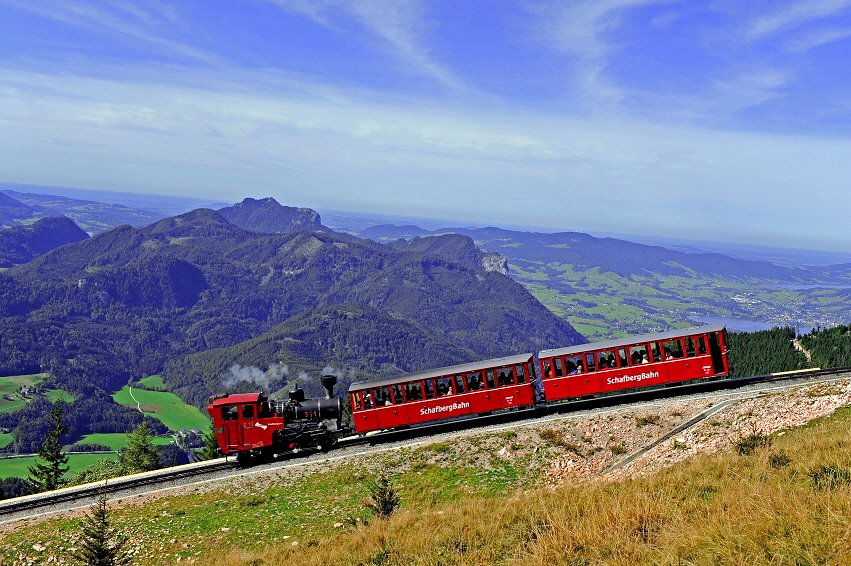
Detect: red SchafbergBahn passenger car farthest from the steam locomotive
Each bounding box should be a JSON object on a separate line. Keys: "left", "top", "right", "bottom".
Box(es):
{"left": 539, "top": 325, "right": 729, "bottom": 401}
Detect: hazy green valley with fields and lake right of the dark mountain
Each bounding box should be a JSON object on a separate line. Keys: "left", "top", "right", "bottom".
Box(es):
{"left": 357, "top": 225, "right": 851, "bottom": 340}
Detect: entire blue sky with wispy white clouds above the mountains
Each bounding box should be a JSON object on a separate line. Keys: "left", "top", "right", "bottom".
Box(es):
{"left": 0, "top": 0, "right": 851, "bottom": 250}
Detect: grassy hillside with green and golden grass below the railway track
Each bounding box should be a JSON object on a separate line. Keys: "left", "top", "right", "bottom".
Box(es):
{"left": 2, "top": 387, "right": 851, "bottom": 566}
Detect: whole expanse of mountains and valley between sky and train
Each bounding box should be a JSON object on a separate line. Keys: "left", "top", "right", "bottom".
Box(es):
{"left": 0, "top": 184, "right": 851, "bottom": 451}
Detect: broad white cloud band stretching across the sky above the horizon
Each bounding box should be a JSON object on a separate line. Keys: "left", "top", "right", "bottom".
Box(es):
{"left": 0, "top": 61, "right": 851, "bottom": 248}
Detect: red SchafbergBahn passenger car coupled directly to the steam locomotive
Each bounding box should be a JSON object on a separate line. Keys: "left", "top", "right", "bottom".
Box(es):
{"left": 349, "top": 354, "right": 535, "bottom": 433}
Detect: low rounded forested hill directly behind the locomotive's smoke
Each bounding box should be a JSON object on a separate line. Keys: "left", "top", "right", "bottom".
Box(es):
{"left": 170, "top": 304, "right": 477, "bottom": 404}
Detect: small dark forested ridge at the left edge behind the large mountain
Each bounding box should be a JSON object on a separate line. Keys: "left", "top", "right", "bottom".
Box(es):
{"left": 0, "top": 216, "right": 89, "bottom": 267}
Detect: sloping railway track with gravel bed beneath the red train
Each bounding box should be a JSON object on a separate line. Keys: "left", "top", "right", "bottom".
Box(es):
{"left": 0, "top": 367, "right": 851, "bottom": 528}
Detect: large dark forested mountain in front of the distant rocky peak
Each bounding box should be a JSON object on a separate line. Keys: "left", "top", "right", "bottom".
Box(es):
{"left": 0, "top": 205, "right": 584, "bottom": 449}
